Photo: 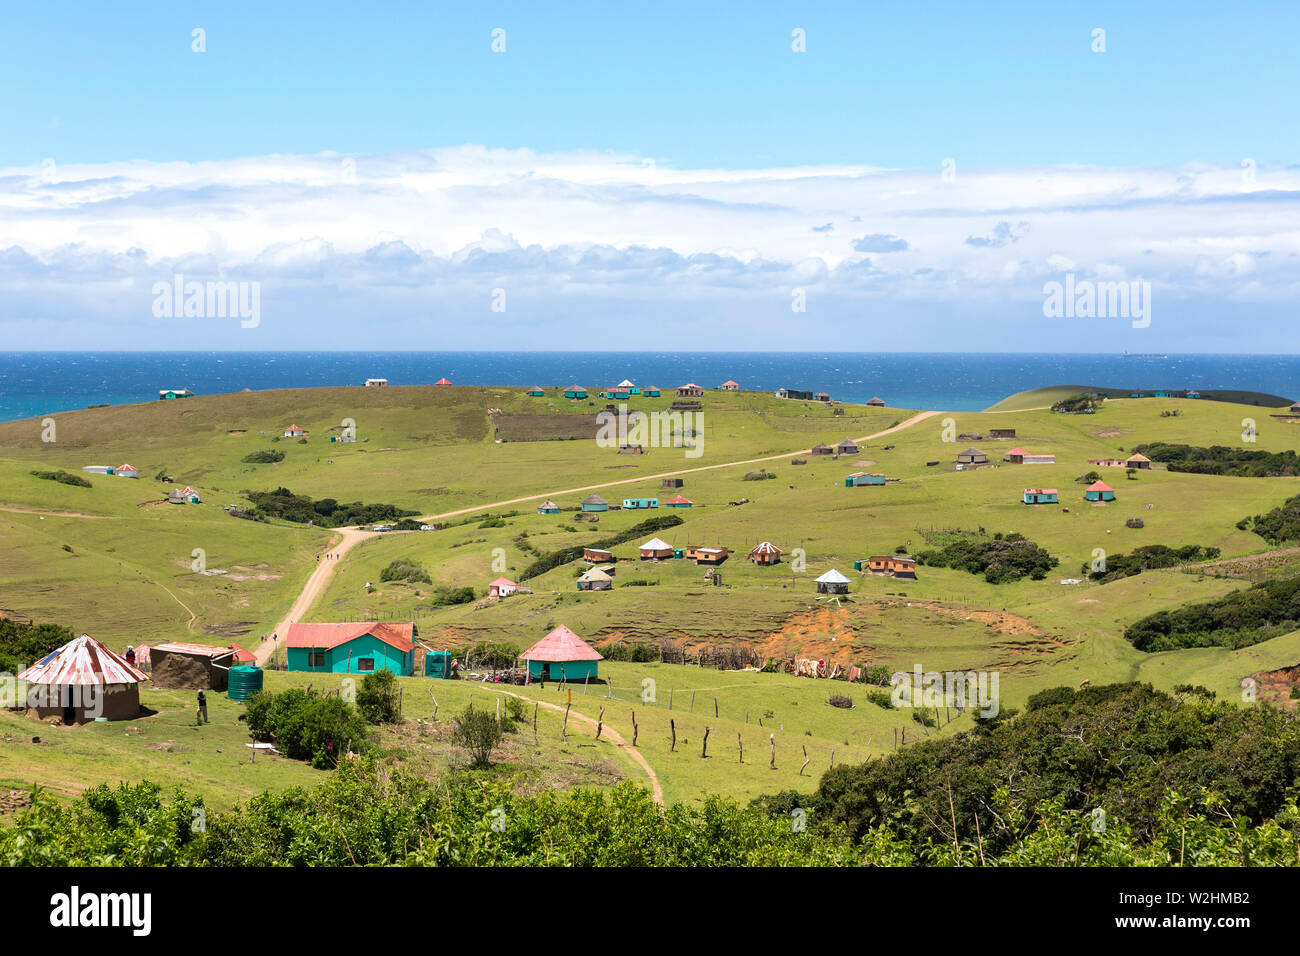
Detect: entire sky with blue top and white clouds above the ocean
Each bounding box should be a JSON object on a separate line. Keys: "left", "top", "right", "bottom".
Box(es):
{"left": 0, "top": 1, "right": 1300, "bottom": 351}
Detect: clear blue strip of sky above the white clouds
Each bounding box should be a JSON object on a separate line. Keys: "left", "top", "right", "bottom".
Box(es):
{"left": 0, "top": 0, "right": 1300, "bottom": 168}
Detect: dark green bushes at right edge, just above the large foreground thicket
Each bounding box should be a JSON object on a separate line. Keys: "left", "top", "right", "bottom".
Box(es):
{"left": 1125, "top": 576, "right": 1300, "bottom": 650}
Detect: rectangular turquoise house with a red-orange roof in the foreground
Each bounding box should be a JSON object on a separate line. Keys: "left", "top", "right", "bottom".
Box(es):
{"left": 285, "top": 620, "right": 415, "bottom": 676}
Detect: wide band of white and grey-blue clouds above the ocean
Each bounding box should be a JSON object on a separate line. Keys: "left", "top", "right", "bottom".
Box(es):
{"left": 0, "top": 146, "right": 1300, "bottom": 352}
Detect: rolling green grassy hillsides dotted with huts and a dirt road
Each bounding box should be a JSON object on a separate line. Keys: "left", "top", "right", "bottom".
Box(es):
{"left": 0, "top": 386, "right": 1300, "bottom": 804}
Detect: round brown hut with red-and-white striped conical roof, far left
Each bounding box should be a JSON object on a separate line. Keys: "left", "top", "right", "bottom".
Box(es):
{"left": 18, "top": 633, "right": 148, "bottom": 724}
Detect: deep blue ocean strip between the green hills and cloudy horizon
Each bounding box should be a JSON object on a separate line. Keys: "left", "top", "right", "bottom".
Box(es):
{"left": 0, "top": 351, "right": 1300, "bottom": 420}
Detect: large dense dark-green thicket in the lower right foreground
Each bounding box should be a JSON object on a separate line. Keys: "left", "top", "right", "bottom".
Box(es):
{"left": 758, "top": 683, "right": 1300, "bottom": 865}
